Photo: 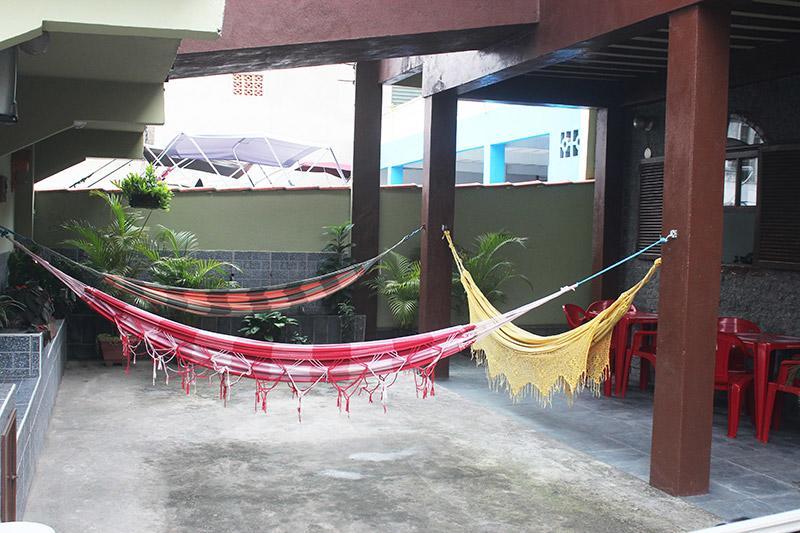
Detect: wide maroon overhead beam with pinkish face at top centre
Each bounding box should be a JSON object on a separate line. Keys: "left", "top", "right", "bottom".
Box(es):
{"left": 171, "top": 0, "right": 539, "bottom": 77}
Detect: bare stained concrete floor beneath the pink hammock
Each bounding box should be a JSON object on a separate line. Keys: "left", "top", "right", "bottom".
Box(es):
{"left": 25, "top": 362, "right": 719, "bottom": 533}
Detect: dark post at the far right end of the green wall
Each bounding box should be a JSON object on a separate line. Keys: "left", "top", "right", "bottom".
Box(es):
{"left": 592, "top": 108, "right": 624, "bottom": 300}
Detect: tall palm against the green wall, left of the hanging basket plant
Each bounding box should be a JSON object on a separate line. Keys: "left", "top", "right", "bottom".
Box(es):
{"left": 63, "top": 190, "right": 146, "bottom": 276}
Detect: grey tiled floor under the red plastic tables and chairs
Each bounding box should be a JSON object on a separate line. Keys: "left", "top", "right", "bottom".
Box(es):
{"left": 440, "top": 357, "right": 800, "bottom": 520}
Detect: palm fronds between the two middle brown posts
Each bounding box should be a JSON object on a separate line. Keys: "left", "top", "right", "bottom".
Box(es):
{"left": 369, "top": 252, "right": 420, "bottom": 329}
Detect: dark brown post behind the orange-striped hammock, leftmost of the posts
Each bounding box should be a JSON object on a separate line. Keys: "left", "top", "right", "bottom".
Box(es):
{"left": 350, "top": 61, "right": 383, "bottom": 339}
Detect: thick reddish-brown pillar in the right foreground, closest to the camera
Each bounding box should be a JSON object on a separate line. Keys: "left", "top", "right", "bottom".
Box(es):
{"left": 650, "top": 4, "right": 730, "bottom": 496}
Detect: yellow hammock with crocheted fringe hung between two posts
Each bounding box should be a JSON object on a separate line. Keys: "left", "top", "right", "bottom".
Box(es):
{"left": 445, "top": 231, "right": 661, "bottom": 405}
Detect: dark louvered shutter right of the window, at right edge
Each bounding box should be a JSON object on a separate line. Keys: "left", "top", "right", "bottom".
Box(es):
{"left": 756, "top": 146, "right": 800, "bottom": 269}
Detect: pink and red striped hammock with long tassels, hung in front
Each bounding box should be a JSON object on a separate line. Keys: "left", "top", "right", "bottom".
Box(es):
{"left": 14, "top": 237, "right": 588, "bottom": 415}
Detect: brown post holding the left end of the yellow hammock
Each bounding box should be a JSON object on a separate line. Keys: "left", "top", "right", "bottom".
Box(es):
{"left": 419, "top": 91, "right": 458, "bottom": 378}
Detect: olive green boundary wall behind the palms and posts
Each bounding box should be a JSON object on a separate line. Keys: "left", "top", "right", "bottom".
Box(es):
{"left": 35, "top": 182, "right": 594, "bottom": 327}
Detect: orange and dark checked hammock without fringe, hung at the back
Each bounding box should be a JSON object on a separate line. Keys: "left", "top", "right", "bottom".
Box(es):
{"left": 80, "top": 228, "right": 422, "bottom": 316}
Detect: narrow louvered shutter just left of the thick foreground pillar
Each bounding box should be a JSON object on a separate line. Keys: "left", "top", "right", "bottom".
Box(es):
{"left": 636, "top": 157, "right": 664, "bottom": 259}
